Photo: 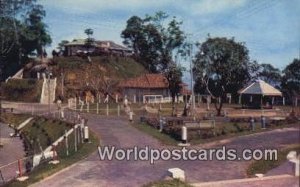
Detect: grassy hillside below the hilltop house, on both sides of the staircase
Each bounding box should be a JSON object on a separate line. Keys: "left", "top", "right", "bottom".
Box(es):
{"left": 1, "top": 56, "right": 146, "bottom": 102}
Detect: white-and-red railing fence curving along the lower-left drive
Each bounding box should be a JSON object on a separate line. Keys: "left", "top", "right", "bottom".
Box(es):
{"left": 0, "top": 107, "right": 87, "bottom": 186}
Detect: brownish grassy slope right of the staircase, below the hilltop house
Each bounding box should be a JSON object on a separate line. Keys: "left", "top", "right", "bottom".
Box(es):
{"left": 52, "top": 56, "right": 147, "bottom": 97}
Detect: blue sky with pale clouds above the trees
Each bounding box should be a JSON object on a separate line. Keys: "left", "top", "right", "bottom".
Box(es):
{"left": 39, "top": 0, "right": 300, "bottom": 70}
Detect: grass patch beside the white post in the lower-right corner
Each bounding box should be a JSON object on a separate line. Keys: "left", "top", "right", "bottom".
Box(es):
{"left": 247, "top": 144, "right": 300, "bottom": 177}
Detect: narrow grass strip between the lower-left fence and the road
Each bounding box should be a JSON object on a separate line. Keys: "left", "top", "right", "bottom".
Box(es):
{"left": 5, "top": 132, "right": 99, "bottom": 187}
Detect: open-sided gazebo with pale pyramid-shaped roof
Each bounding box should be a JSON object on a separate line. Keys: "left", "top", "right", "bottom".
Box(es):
{"left": 238, "top": 80, "right": 284, "bottom": 108}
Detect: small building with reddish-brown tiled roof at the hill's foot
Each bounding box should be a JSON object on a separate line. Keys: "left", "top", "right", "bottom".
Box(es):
{"left": 119, "top": 74, "right": 170, "bottom": 103}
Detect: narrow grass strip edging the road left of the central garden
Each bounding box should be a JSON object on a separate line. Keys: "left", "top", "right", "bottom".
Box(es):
{"left": 132, "top": 123, "right": 178, "bottom": 145}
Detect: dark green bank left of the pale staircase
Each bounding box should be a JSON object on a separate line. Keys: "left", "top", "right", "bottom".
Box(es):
{"left": 1, "top": 79, "right": 43, "bottom": 102}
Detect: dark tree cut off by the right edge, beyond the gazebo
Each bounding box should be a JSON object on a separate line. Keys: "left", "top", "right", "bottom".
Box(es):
{"left": 281, "top": 59, "right": 300, "bottom": 103}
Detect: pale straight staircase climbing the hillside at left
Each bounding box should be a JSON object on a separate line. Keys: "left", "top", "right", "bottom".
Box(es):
{"left": 40, "top": 78, "right": 56, "bottom": 104}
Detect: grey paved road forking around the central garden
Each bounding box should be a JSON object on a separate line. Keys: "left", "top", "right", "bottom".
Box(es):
{"left": 33, "top": 115, "right": 300, "bottom": 187}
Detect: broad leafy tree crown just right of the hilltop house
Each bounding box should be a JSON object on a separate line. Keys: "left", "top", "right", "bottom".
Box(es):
{"left": 121, "top": 12, "right": 185, "bottom": 72}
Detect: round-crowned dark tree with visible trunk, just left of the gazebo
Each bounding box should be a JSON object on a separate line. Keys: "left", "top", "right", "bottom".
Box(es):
{"left": 193, "top": 38, "right": 253, "bottom": 115}
